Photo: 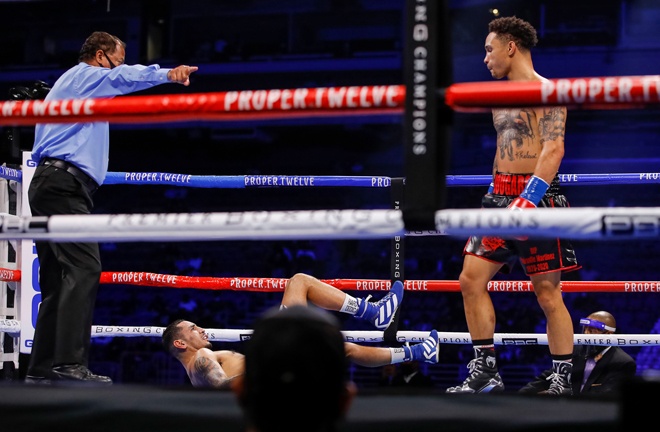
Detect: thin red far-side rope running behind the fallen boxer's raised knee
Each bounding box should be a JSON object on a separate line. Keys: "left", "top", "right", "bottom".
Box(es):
{"left": 0, "top": 268, "right": 660, "bottom": 293}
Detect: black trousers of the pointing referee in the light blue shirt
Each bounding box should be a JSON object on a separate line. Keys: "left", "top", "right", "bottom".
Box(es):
{"left": 27, "top": 165, "right": 101, "bottom": 377}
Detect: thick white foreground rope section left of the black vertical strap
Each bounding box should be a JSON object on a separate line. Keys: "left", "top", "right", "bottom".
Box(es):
{"left": 0, "top": 210, "right": 403, "bottom": 242}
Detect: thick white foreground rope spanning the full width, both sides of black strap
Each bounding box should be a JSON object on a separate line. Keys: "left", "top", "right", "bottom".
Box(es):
{"left": 0, "top": 207, "right": 660, "bottom": 242}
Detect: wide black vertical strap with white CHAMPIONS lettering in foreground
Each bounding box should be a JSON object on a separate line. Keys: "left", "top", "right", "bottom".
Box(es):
{"left": 403, "top": 0, "right": 453, "bottom": 231}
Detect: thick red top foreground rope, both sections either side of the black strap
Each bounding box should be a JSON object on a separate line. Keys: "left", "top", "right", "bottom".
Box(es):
{"left": 5, "top": 75, "right": 660, "bottom": 126}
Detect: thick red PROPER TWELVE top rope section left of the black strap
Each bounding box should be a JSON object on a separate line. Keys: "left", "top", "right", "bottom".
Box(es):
{"left": 0, "top": 85, "right": 406, "bottom": 125}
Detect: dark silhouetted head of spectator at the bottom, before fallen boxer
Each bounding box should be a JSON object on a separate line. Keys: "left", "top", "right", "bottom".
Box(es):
{"left": 233, "top": 306, "right": 356, "bottom": 432}
